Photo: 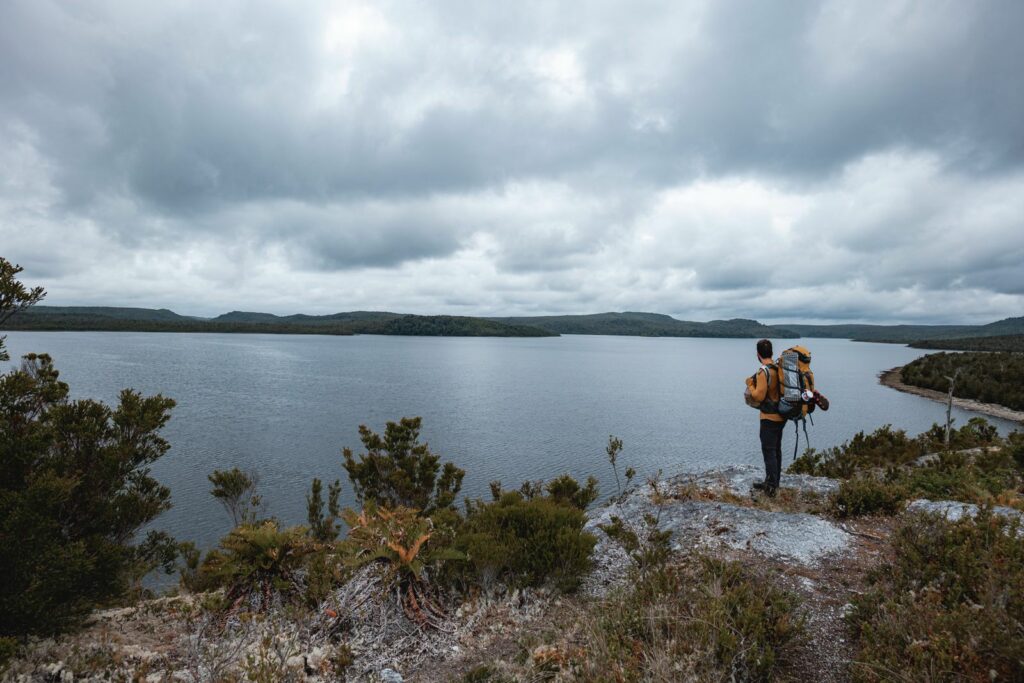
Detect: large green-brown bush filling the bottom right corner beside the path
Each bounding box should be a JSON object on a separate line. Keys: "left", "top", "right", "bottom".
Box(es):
{"left": 849, "top": 508, "right": 1024, "bottom": 681}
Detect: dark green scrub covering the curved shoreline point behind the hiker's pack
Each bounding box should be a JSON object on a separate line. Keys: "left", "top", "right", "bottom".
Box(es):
{"left": 900, "top": 352, "right": 1024, "bottom": 411}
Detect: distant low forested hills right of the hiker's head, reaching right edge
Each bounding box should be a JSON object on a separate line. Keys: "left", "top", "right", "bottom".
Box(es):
{"left": 782, "top": 317, "right": 1024, "bottom": 348}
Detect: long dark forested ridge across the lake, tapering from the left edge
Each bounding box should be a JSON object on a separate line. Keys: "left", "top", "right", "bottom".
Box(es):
{"left": 4, "top": 306, "right": 554, "bottom": 337}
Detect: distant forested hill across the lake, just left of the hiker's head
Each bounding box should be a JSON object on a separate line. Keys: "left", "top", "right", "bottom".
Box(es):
{"left": 490, "top": 311, "right": 800, "bottom": 339}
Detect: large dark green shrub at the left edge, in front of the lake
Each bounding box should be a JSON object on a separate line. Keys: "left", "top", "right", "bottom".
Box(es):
{"left": 0, "top": 354, "right": 174, "bottom": 635}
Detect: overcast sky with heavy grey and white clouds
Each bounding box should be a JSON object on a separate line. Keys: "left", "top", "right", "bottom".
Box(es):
{"left": 0, "top": 0, "right": 1024, "bottom": 323}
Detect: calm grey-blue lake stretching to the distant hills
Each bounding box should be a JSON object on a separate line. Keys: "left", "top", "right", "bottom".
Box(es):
{"left": 7, "top": 332, "right": 1015, "bottom": 546}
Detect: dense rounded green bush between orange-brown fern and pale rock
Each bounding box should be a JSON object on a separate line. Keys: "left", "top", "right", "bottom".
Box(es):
{"left": 454, "top": 484, "right": 597, "bottom": 591}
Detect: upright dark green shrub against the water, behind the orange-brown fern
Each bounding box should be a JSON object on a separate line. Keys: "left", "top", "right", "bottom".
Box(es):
{"left": 343, "top": 418, "right": 466, "bottom": 515}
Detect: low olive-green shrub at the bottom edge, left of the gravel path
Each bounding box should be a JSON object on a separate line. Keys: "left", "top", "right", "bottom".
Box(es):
{"left": 579, "top": 557, "right": 803, "bottom": 682}
